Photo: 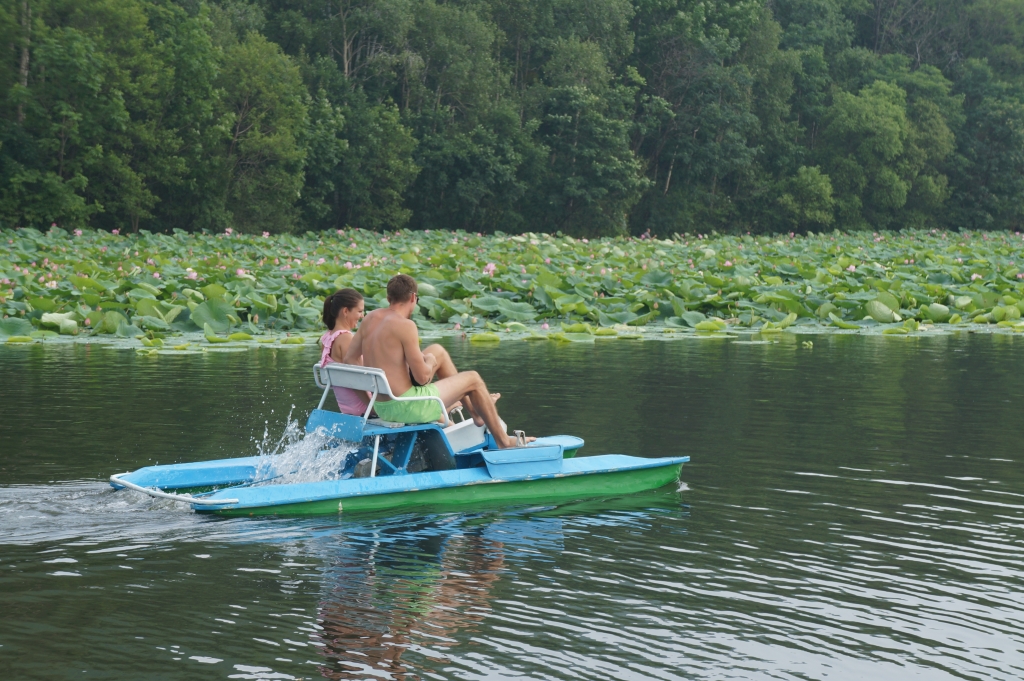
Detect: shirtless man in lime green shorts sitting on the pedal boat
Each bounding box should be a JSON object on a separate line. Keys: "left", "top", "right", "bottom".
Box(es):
{"left": 345, "top": 274, "right": 534, "bottom": 449}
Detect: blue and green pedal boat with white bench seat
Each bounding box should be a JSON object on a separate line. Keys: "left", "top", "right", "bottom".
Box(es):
{"left": 110, "top": 363, "right": 689, "bottom": 516}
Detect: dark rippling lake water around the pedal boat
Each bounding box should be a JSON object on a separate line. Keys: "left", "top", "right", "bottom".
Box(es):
{"left": 0, "top": 334, "right": 1024, "bottom": 681}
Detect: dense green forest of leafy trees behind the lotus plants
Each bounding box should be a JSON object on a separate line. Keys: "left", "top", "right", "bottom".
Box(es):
{"left": 0, "top": 0, "right": 1024, "bottom": 236}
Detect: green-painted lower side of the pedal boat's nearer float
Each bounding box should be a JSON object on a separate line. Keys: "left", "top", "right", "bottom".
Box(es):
{"left": 196, "top": 459, "right": 683, "bottom": 516}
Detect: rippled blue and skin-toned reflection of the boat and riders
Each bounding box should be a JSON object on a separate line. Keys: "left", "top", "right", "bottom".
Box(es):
{"left": 318, "top": 517, "right": 562, "bottom": 679}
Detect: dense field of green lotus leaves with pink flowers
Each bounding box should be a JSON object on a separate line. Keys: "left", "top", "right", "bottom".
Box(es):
{"left": 0, "top": 227, "right": 1024, "bottom": 353}
